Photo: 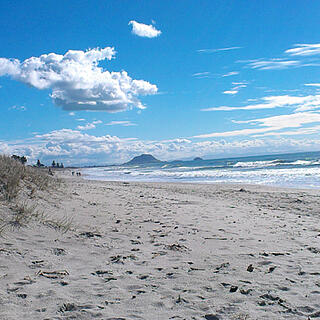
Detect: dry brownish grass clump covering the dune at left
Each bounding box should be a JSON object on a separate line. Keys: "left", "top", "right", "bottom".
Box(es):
{"left": 0, "top": 155, "right": 72, "bottom": 235}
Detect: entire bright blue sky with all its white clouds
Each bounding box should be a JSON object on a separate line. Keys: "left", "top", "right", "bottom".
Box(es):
{"left": 0, "top": 0, "right": 320, "bottom": 165}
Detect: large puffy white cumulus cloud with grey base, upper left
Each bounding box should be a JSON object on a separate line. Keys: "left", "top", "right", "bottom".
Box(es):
{"left": 0, "top": 47, "right": 158, "bottom": 112}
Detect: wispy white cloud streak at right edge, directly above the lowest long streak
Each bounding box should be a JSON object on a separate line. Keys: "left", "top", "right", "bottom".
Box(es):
{"left": 201, "top": 95, "right": 320, "bottom": 111}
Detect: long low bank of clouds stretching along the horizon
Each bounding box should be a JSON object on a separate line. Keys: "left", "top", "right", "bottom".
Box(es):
{"left": 0, "top": 129, "right": 320, "bottom": 165}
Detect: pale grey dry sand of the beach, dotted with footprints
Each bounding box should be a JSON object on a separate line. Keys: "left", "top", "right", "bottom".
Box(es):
{"left": 0, "top": 171, "right": 320, "bottom": 320}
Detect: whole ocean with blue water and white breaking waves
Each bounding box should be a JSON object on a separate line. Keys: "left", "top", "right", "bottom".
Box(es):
{"left": 82, "top": 152, "right": 320, "bottom": 188}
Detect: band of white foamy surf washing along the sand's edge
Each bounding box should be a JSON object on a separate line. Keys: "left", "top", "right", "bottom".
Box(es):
{"left": 85, "top": 167, "right": 320, "bottom": 187}
